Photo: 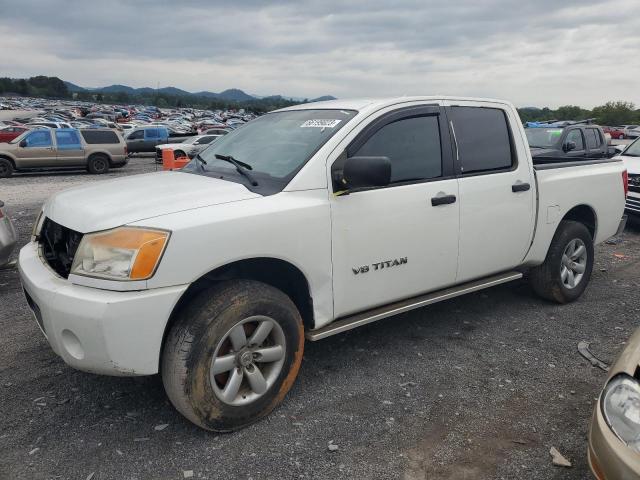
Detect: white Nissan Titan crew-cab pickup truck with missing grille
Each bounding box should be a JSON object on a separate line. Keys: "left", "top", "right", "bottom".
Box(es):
{"left": 19, "top": 97, "right": 626, "bottom": 431}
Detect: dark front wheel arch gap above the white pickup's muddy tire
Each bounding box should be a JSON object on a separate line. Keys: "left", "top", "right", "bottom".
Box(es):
{"left": 158, "top": 257, "right": 314, "bottom": 368}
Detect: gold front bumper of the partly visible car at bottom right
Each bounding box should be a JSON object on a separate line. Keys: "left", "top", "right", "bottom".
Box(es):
{"left": 588, "top": 398, "right": 640, "bottom": 480}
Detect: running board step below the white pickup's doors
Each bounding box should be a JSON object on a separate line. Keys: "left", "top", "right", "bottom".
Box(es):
{"left": 306, "top": 272, "right": 522, "bottom": 341}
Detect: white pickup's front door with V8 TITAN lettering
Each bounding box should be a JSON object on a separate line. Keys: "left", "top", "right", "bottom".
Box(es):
{"left": 330, "top": 106, "right": 459, "bottom": 317}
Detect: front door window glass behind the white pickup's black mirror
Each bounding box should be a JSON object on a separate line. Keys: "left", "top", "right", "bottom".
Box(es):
{"left": 354, "top": 116, "right": 442, "bottom": 183}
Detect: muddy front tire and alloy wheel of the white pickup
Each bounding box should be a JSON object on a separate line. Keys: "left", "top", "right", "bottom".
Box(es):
{"left": 161, "top": 280, "right": 304, "bottom": 432}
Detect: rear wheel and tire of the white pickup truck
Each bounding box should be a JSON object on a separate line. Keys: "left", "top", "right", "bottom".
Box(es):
{"left": 529, "top": 220, "right": 594, "bottom": 303}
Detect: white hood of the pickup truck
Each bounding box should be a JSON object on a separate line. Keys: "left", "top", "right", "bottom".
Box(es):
{"left": 44, "top": 172, "right": 260, "bottom": 233}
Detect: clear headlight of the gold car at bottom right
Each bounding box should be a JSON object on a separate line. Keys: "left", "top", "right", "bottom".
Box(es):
{"left": 602, "top": 375, "right": 640, "bottom": 452}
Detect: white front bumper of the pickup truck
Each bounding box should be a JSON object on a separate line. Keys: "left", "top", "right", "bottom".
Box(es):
{"left": 18, "top": 242, "right": 188, "bottom": 376}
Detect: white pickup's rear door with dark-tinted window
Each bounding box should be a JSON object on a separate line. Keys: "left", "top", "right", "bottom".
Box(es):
{"left": 447, "top": 102, "right": 535, "bottom": 283}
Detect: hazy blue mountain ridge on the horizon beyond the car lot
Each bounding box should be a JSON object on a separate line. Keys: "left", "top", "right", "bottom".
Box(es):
{"left": 64, "top": 82, "right": 336, "bottom": 102}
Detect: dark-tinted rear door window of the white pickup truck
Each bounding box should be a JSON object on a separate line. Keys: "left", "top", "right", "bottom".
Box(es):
{"left": 450, "top": 107, "right": 515, "bottom": 173}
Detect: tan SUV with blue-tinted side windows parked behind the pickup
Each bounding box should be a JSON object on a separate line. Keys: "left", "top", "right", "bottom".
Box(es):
{"left": 0, "top": 128, "right": 128, "bottom": 178}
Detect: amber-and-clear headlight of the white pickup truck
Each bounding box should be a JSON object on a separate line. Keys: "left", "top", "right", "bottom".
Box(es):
{"left": 71, "top": 227, "right": 169, "bottom": 280}
